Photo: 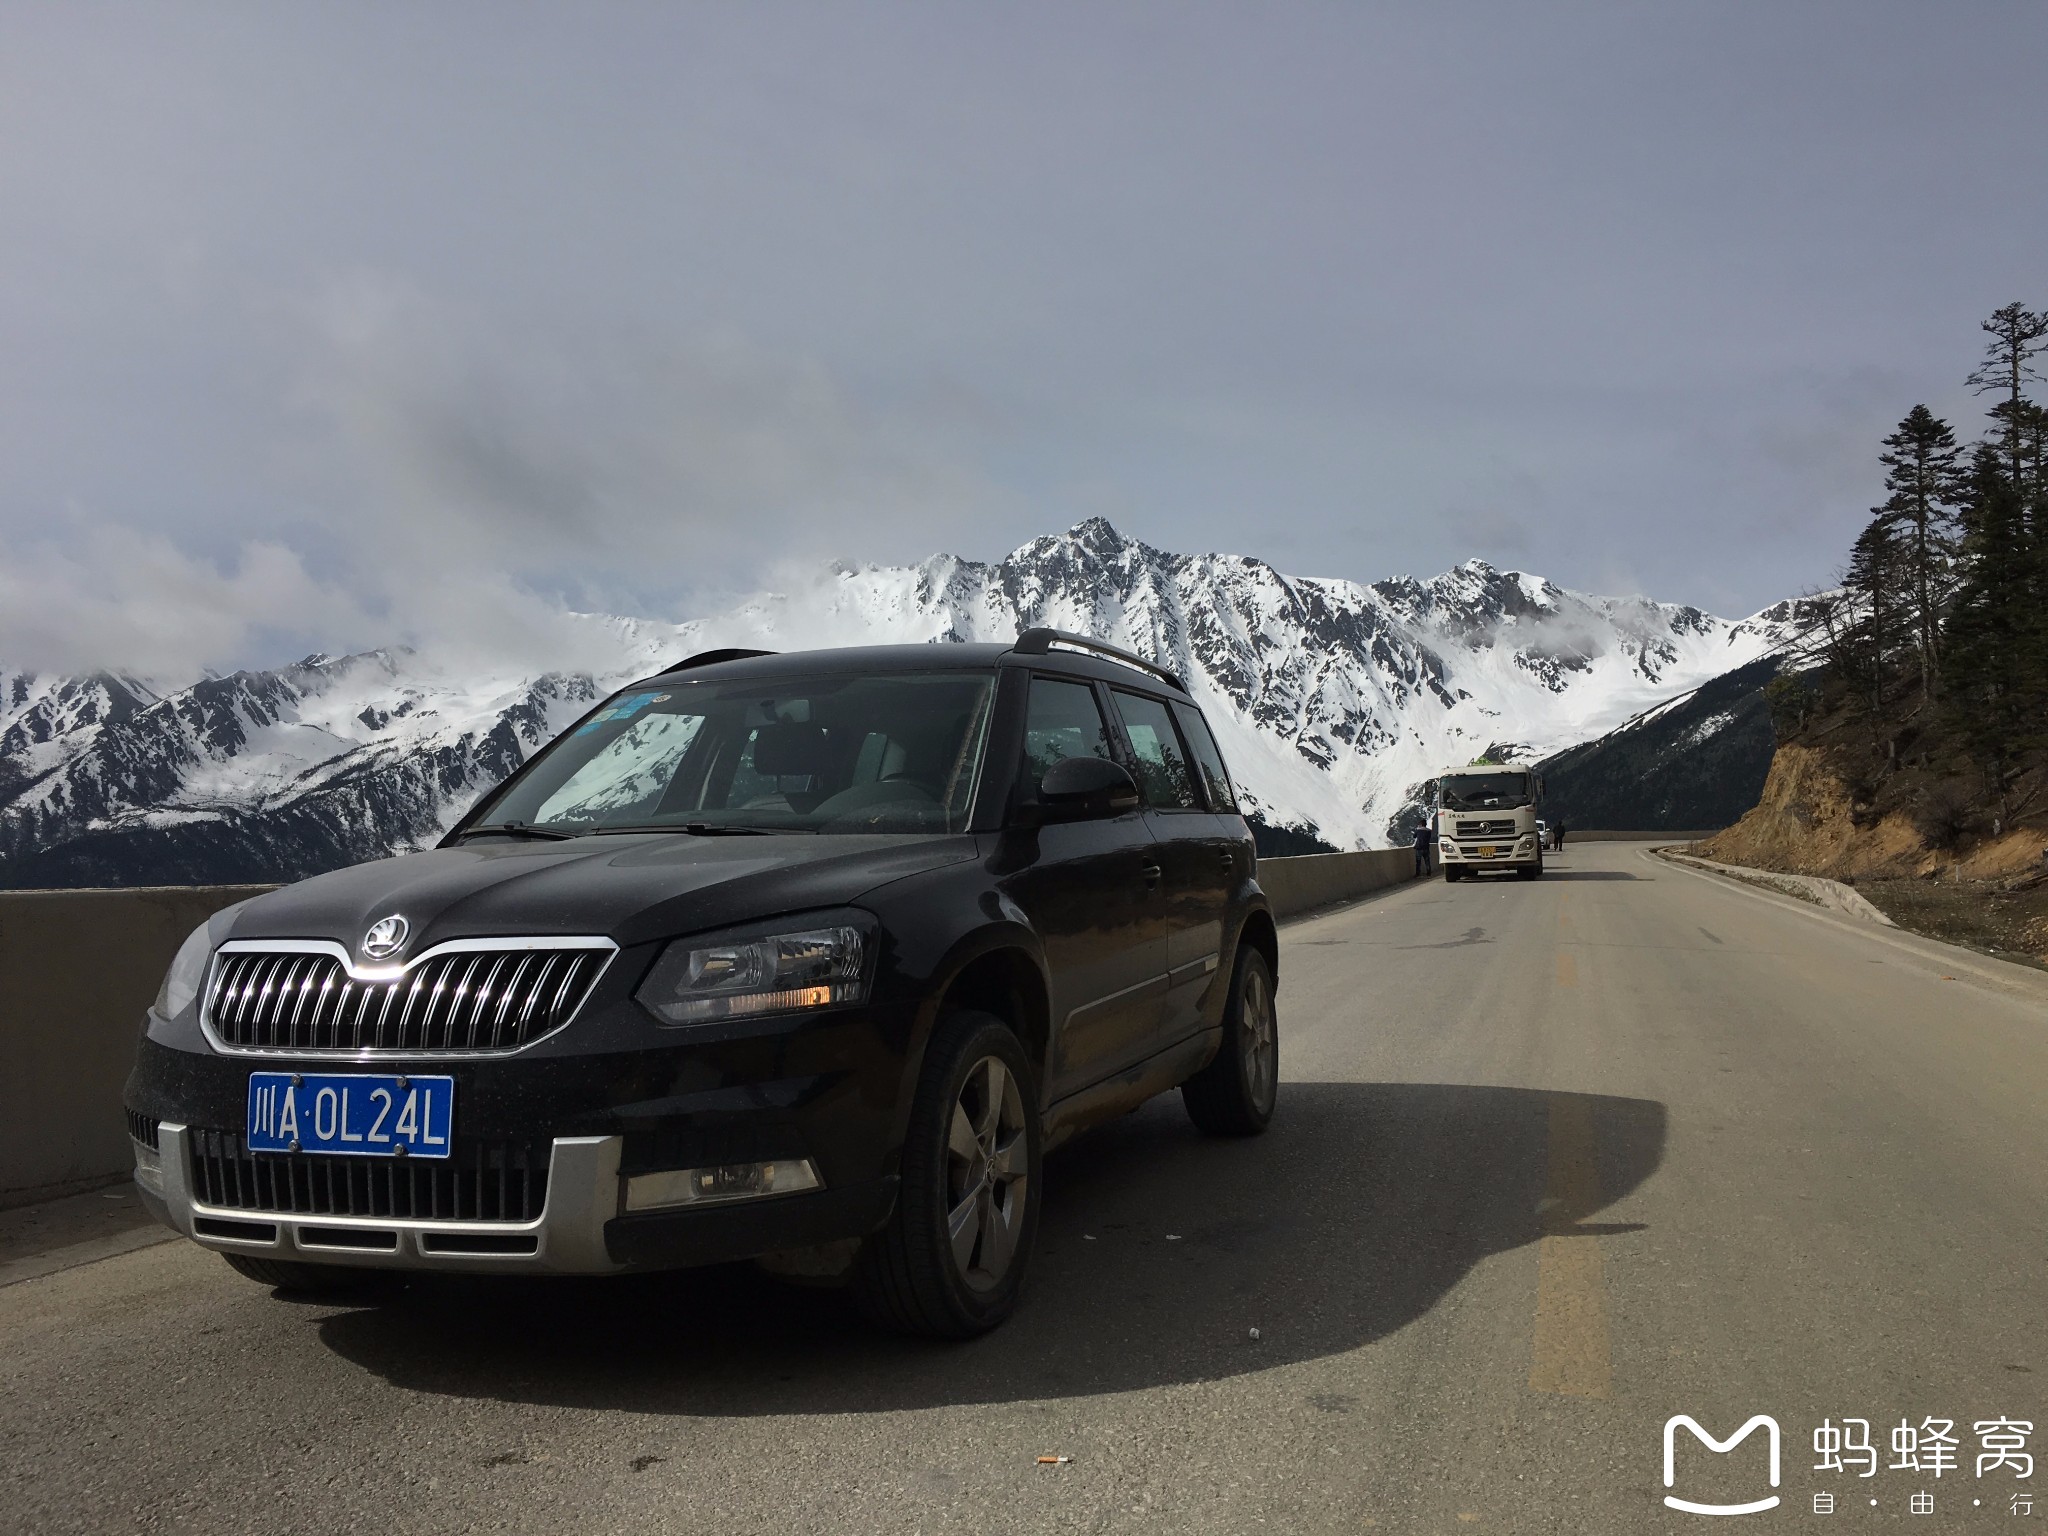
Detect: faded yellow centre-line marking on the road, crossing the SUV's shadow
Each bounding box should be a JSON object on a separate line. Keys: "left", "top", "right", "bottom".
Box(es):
{"left": 1530, "top": 1089, "right": 1614, "bottom": 1397}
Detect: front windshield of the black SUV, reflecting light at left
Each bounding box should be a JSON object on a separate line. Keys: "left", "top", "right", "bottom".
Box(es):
{"left": 469, "top": 672, "right": 993, "bottom": 834}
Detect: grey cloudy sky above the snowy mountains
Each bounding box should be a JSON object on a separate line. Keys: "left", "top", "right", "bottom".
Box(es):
{"left": 0, "top": 0, "right": 2048, "bottom": 672}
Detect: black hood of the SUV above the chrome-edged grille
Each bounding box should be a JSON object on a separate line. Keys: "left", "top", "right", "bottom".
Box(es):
{"left": 225, "top": 834, "right": 979, "bottom": 961}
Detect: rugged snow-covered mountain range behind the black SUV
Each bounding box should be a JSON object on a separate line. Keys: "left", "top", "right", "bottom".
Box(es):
{"left": 0, "top": 518, "right": 1826, "bottom": 887}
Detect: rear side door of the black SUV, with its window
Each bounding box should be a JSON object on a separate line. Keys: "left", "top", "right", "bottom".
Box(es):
{"left": 1110, "top": 688, "right": 1233, "bottom": 1049}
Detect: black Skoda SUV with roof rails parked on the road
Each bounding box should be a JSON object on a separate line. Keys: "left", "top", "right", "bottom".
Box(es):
{"left": 127, "top": 629, "right": 1278, "bottom": 1337}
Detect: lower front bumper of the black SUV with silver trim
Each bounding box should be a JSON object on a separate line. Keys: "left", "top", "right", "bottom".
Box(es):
{"left": 135, "top": 1124, "right": 895, "bottom": 1274}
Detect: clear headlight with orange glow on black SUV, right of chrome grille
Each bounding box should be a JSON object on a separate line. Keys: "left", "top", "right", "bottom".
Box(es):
{"left": 635, "top": 924, "right": 868, "bottom": 1024}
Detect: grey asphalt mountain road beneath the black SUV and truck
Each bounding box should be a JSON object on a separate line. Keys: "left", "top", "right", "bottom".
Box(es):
{"left": 0, "top": 844, "right": 2048, "bottom": 1536}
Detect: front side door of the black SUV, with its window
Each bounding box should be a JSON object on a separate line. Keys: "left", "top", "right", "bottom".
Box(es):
{"left": 1004, "top": 676, "right": 1165, "bottom": 1102}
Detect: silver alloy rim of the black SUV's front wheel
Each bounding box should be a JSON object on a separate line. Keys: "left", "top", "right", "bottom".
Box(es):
{"left": 946, "top": 1057, "right": 1030, "bottom": 1290}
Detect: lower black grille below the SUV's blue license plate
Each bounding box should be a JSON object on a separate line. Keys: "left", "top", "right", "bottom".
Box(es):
{"left": 190, "top": 1128, "right": 553, "bottom": 1221}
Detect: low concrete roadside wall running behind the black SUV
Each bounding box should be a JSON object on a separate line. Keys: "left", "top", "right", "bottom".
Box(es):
{"left": 0, "top": 848, "right": 1415, "bottom": 1208}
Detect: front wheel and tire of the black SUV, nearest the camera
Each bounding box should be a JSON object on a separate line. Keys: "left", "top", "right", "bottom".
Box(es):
{"left": 854, "top": 1012, "right": 1044, "bottom": 1339}
